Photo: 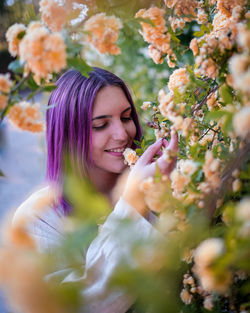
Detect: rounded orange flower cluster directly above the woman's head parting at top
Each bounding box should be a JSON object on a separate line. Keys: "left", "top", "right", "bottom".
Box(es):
{"left": 84, "top": 13, "right": 122, "bottom": 55}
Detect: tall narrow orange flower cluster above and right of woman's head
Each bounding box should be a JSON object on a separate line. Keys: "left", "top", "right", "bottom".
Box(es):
{"left": 136, "top": 7, "right": 176, "bottom": 67}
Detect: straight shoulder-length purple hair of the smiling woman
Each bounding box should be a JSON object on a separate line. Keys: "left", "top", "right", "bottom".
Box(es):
{"left": 46, "top": 67, "right": 142, "bottom": 214}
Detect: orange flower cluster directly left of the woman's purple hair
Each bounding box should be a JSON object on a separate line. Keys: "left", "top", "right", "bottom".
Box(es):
{"left": 8, "top": 101, "right": 44, "bottom": 133}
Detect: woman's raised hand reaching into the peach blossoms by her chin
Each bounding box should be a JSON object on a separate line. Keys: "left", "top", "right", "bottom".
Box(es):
{"left": 122, "top": 132, "right": 178, "bottom": 216}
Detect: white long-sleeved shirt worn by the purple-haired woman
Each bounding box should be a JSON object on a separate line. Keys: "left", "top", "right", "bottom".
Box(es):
{"left": 13, "top": 187, "right": 159, "bottom": 313}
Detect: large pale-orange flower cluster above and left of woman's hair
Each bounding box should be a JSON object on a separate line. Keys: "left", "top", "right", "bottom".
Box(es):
{"left": 20, "top": 22, "right": 66, "bottom": 84}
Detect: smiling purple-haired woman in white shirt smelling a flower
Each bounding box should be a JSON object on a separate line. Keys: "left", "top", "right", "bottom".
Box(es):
{"left": 13, "top": 68, "right": 177, "bottom": 313}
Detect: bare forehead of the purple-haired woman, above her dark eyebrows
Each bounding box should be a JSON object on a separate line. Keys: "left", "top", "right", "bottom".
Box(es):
{"left": 92, "top": 86, "right": 130, "bottom": 117}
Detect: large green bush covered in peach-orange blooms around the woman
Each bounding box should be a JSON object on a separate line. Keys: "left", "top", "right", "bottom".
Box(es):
{"left": 0, "top": 0, "right": 250, "bottom": 312}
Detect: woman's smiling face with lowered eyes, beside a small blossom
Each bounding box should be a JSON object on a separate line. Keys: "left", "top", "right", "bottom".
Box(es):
{"left": 92, "top": 86, "right": 136, "bottom": 173}
